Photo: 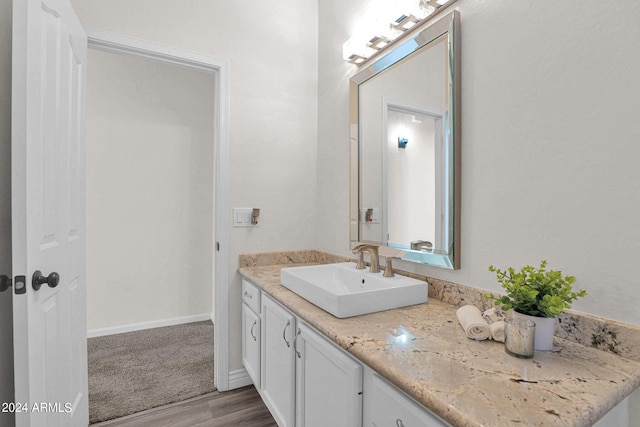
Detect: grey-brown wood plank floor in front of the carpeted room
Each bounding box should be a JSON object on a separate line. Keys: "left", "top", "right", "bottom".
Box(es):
{"left": 91, "top": 386, "right": 277, "bottom": 427}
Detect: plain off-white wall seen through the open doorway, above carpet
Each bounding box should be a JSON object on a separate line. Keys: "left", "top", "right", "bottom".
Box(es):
{"left": 86, "top": 49, "right": 215, "bottom": 330}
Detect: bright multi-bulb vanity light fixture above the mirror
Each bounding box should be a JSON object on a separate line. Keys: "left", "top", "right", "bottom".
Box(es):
{"left": 342, "top": 0, "right": 456, "bottom": 65}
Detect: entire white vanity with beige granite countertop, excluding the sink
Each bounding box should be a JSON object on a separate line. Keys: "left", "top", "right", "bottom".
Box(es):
{"left": 239, "top": 251, "right": 640, "bottom": 426}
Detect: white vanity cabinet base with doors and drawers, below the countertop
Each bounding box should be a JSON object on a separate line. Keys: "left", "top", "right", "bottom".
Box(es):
{"left": 242, "top": 279, "right": 447, "bottom": 427}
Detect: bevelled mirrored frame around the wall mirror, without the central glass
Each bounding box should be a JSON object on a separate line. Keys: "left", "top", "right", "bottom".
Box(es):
{"left": 349, "top": 10, "right": 460, "bottom": 269}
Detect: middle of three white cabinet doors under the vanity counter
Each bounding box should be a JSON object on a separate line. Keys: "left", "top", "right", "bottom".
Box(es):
{"left": 260, "top": 294, "right": 296, "bottom": 427}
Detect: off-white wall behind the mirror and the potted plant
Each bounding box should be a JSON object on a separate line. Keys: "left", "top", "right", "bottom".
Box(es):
{"left": 318, "top": 0, "right": 640, "bottom": 324}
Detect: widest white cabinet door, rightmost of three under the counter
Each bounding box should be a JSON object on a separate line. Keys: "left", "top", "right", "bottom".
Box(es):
{"left": 294, "top": 324, "right": 362, "bottom": 427}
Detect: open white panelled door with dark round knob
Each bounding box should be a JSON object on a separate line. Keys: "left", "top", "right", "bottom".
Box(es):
{"left": 11, "top": 0, "right": 89, "bottom": 427}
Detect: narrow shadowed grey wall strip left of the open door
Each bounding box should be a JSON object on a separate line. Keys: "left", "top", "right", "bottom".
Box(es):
{"left": 0, "top": 0, "right": 14, "bottom": 426}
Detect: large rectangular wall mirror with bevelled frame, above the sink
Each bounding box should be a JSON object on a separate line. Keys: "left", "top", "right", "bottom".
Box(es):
{"left": 349, "top": 11, "right": 460, "bottom": 269}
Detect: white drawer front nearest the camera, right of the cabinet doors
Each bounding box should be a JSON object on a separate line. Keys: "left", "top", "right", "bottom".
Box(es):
{"left": 364, "top": 373, "right": 447, "bottom": 427}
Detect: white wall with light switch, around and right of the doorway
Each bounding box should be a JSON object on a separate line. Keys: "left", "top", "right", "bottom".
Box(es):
{"left": 72, "top": 0, "right": 318, "bottom": 370}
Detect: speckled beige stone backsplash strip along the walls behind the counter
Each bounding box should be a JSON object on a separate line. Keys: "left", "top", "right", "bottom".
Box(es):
{"left": 240, "top": 249, "right": 640, "bottom": 362}
